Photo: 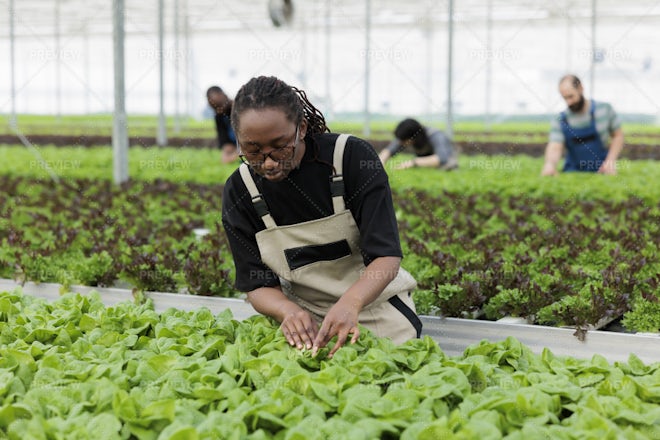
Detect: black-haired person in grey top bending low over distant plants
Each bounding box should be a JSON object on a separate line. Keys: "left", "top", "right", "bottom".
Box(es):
{"left": 379, "top": 118, "right": 458, "bottom": 170}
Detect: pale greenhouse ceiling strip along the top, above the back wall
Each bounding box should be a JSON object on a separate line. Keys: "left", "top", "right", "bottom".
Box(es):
{"left": 0, "top": 0, "right": 660, "bottom": 38}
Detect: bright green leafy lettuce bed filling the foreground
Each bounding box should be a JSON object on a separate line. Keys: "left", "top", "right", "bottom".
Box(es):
{"left": 0, "top": 289, "right": 660, "bottom": 440}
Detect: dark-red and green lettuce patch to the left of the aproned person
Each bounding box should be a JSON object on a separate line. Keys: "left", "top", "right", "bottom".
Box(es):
{"left": 0, "top": 176, "right": 234, "bottom": 296}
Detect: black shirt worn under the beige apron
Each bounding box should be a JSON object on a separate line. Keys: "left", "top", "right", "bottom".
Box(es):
{"left": 222, "top": 133, "right": 402, "bottom": 292}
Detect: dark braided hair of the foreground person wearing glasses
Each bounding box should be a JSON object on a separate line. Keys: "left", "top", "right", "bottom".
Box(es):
{"left": 231, "top": 76, "right": 330, "bottom": 138}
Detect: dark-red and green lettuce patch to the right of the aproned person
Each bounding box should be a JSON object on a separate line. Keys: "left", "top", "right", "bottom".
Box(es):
{"left": 395, "top": 182, "right": 660, "bottom": 330}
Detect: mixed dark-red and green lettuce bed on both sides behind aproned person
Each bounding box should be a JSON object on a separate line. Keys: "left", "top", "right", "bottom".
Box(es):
{"left": 0, "top": 171, "right": 660, "bottom": 331}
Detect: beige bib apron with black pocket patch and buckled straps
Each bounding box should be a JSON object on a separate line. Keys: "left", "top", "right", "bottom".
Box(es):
{"left": 239, "top": 135, "right": 422, "bottom": 343}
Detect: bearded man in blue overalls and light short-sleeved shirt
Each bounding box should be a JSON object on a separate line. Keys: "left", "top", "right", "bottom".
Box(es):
{"left": 541, "top": 75, "right": 623, "bottom": 176}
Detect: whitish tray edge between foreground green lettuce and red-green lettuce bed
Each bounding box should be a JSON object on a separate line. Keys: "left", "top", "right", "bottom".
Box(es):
{"left": 0, "top": 279, "right": 660, "bottom": 363}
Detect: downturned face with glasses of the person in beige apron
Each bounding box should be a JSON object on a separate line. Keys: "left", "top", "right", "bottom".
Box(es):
{"left": 236, "top": 108, "right": 307, "bottom": 182}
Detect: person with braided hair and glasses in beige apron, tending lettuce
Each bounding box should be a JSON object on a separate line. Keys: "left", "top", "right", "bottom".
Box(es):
{"left": 222, "top": 76, "right": 421, "bottom": 357}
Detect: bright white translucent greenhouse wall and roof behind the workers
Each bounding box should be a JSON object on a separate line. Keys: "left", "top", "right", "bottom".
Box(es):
{"left": 0, "top": 0, "right": 660, "bottom": 182}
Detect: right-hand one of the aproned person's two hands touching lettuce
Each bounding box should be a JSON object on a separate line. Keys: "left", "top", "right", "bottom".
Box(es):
{"left": 312, "top": 299, "right": 360, "bottom": 358}
